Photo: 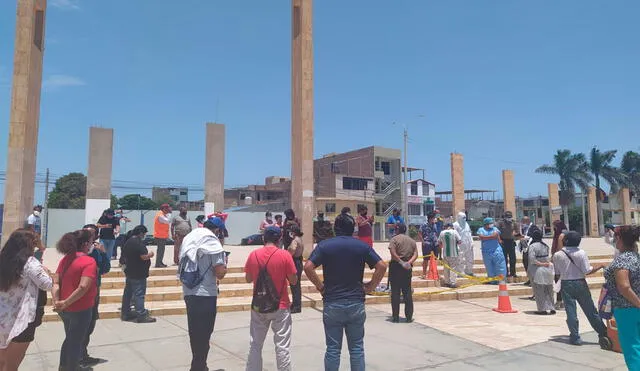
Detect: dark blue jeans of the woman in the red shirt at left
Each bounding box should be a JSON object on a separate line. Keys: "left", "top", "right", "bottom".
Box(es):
{"left": 59, "top": 308, "right": 93, "bottom": 371}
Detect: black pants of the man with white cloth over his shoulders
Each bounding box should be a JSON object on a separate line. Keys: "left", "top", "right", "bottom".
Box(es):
{"left": 184, "top": 295, "right": 218, "bottom": 371}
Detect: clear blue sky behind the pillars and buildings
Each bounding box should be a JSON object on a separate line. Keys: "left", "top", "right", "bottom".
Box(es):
{"left": 0, "top": 0, "right": 640, "bottom": 203}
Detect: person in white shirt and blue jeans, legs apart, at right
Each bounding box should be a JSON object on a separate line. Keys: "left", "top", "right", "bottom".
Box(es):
{"left": 553, "top": 231, "right": 608, "bottom": 347}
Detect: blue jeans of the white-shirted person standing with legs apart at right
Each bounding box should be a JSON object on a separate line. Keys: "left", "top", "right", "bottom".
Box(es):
{"left": 561, "top": 279, "right": 607, "bottom": 342}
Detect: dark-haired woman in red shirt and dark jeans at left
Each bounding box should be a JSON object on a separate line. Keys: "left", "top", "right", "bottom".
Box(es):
{"left": 51, "top": 230, "right": 98, "bottom": 370}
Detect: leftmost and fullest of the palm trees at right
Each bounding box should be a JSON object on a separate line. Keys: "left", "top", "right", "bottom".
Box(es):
{"left": 536, "top": 149, "right": 592, "bottom": 228}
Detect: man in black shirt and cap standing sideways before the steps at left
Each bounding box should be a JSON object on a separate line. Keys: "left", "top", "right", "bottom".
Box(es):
{"left": 120, "top": 225, "right": 156, "bottom": 323}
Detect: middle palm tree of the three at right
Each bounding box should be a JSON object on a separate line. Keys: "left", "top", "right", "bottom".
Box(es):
{"left": 589, "top": 147, "right": 626, "bottom": 234}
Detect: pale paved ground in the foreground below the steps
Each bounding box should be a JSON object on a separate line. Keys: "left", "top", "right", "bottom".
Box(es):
{"left": 22, "top": 298, "right": 626, "bottom": 371}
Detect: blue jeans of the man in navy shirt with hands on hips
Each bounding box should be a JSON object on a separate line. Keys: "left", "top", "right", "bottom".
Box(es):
{"left": 322, "top": 300, "right": 367, "bottom": 371}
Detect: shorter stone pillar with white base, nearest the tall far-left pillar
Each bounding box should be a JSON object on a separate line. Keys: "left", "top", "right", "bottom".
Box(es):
{"left": 84, "top": 127, "right": 113, "bottom": 224}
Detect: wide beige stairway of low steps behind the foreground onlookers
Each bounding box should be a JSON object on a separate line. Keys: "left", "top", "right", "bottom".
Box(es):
{"left": 44, "top": 255, "right": 612, "bottom": 321}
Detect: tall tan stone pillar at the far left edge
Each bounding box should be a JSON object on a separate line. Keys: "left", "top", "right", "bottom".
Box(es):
{"left": 0, "top": 0, "right": 47, "bottom": 248}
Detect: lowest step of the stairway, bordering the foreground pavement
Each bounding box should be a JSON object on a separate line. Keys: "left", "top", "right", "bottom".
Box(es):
{"left": 44, "top": 277, "right": 604, "bottom": 321}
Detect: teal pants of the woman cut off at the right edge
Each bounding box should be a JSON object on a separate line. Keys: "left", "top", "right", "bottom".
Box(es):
{"left": 613, "top": 308, "right": 640, "bottom": 370}
